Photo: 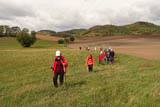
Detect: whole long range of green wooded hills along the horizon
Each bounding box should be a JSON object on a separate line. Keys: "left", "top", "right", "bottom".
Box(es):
{"left": 39, "top": 22, "right": 160, "bottom": 37}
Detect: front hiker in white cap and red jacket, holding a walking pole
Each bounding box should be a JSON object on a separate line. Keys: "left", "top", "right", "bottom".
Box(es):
{"left": 52, "top": 51, "right": 68, "bottom": 88}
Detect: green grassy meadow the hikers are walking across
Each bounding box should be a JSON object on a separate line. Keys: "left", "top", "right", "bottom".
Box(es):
{"left": 0, "top": 38, "right": 160, "bottom": 107}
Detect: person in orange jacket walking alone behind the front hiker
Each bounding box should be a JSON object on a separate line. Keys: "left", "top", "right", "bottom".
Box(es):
{"left": 86, "top": 54, "right": 94, "bottom": 72}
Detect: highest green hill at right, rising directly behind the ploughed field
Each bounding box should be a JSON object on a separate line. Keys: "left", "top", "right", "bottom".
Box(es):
{"left": 81, "top": 22, "right": 160, "bottom": 36}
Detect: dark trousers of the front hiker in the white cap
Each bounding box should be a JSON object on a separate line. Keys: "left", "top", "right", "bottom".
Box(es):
{"left": 53, "top": 72, "right": 64, "bottom": 87}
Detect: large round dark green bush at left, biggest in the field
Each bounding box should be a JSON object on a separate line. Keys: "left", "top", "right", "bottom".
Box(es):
{"left": 16, "top": 31, "right": 36, "bottom": 47}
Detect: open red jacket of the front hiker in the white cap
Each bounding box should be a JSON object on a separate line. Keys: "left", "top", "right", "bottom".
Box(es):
{"left": 53, "top": 56, "right": 68, "bottom": 75}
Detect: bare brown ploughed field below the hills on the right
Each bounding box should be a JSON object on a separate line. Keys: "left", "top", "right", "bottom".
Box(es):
{"left": 69, "top": 35, "right": 160, "bottom": 60}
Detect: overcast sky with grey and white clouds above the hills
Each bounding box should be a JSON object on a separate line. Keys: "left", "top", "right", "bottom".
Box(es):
{"left": 0, "top": 0, "right": 160, "bottom": 31}
